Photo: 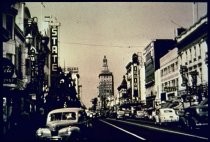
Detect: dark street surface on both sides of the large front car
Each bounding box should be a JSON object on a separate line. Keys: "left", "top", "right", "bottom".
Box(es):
{"left": 3, "top": 118, "right": 208, "bottom": 142}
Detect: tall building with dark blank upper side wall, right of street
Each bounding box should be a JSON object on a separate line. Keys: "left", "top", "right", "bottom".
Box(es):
{"left": 143, "top": 39, "right": 175, "bottom": 108}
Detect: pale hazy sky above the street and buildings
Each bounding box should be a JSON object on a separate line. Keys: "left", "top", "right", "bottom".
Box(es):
{"left": 26, "top": 2, "right": 207, "bottom": 107}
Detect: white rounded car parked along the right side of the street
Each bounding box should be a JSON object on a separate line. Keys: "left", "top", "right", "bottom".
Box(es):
{"left": 154, "top": 108, "right": 179, "bottom": 124}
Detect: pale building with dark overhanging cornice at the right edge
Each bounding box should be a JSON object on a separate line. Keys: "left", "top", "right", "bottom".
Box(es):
{"left": 176, "top": 16, "right": 208, "bottom": 106}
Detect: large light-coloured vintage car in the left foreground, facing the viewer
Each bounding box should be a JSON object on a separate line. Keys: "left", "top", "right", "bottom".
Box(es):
{"left": 36, "top": 108, "right": 91, "bottom": 141}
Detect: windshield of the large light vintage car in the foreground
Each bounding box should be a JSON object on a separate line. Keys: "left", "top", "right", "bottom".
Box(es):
{"left": 50, "top": 112, "right": 76, "bottom": 121}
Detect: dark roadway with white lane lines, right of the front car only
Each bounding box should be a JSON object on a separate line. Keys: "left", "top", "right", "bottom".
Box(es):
{"left": 89, "top": 119, "right": 208, "bottom": 142}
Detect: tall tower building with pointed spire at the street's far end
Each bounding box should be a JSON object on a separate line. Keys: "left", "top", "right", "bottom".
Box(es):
{"left": 99, "top": 56, "right": 114, "bottom": 109}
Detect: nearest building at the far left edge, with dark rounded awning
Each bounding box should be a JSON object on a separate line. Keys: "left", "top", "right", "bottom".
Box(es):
{"left": 0, "top": 3, "right": 18, "bottom": 136}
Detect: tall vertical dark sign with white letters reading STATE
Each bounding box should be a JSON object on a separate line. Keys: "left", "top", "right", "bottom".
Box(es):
{"left": 50, "top": 25, "right": 58, "bottom": 75}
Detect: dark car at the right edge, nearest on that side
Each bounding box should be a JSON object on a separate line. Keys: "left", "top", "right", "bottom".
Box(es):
{"left": 179, "top": 105, "right": 208, "bottom": 129}
